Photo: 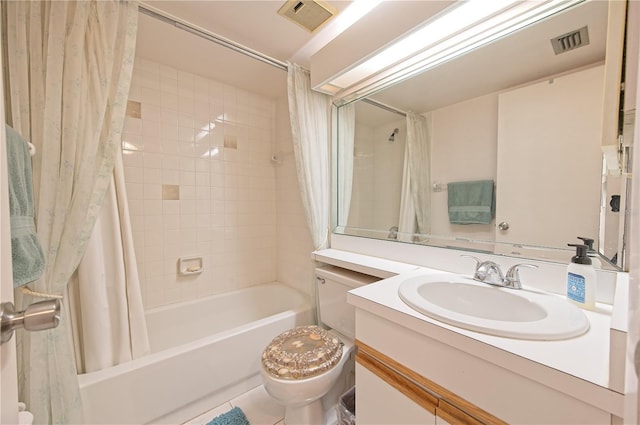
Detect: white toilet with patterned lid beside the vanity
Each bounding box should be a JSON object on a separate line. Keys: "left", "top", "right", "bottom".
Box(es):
{"left": 261, "top": 266, "right": 379, "bottom": 425}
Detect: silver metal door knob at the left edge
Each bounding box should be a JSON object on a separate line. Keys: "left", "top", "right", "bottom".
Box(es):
{"left": 0, "top": 299, "right": 60, "bottom": 344}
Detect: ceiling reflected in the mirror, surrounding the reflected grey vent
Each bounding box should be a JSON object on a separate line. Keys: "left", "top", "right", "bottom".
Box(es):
{"left": 357, "top": 1, "right": 608, "bottom": 125}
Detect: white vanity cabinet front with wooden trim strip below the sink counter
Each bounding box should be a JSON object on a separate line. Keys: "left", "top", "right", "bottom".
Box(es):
{"left": 356, "top": 308, "right": 615, "bottom": 424}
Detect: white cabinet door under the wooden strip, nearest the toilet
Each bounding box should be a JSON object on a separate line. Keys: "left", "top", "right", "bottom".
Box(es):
{"left": 356, "top": 364, "right": 436, "bottom": 425}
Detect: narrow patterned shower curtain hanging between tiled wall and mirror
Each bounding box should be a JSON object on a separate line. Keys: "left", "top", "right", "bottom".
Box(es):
{"left": 287, "top": 64, "right": 329, "bottom": 249}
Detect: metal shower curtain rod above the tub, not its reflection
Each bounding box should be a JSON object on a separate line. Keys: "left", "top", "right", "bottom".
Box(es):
{"left": 138, "top": 3, "right": 287, "bottom": 71}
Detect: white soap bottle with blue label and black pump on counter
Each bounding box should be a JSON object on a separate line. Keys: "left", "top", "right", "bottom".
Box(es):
{"left": 567, "top": 244, "right": 596, "bottom": 310}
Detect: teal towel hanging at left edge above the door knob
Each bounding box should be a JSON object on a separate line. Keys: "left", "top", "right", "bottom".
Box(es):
{"left": 6, "top": 126, "right": 45, "bottom": 288}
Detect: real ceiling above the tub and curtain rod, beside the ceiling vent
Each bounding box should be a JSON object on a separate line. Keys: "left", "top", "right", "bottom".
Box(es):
{"left": 136, "top": 0, "right": 351, "bottom": 98}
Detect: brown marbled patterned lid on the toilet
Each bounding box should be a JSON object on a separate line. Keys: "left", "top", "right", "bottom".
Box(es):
{"left": 262, "top": 326, "right": 342, "bottom": 379}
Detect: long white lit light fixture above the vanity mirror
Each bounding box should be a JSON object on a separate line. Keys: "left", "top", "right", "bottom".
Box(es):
{"left": 327, "top": 0, "right": 585, "bottom": 101}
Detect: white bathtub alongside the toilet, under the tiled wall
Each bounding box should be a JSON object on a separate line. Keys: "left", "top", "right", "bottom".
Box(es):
{"left": 78, "top": 283, "right": 312, "bottom": 424}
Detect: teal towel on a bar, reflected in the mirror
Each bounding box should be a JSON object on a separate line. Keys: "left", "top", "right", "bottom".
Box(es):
{"left": 447, "top": 180, "right": 495, "bottom": 224}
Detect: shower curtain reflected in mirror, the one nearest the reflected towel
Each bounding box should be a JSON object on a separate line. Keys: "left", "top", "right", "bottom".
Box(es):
{"left": 405, "top": 112, "right": 431, "bottom": 235}
